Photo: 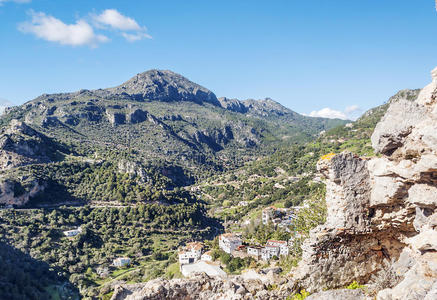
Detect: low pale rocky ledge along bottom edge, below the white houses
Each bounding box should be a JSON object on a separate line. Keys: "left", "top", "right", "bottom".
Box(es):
{"left": 111, "top": 273, "right": 292, "bottom": 300}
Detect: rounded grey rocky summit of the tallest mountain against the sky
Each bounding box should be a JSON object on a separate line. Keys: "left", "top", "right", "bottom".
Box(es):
{"left": 106, "top": 69, "right": 220, "bottom": 106}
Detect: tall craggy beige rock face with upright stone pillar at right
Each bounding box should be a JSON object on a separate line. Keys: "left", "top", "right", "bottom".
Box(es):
{"left": 294, "top": 68, "right": 437, "bottom": 300}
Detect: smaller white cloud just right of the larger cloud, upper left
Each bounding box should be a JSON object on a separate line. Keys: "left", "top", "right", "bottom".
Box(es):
{"left": 93, "top": 9, "right": 152, "bottom": 42}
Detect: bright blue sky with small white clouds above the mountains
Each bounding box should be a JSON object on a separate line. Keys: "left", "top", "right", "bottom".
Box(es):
{"left": 0, "top": 0, "right": 437, "bottom": 117}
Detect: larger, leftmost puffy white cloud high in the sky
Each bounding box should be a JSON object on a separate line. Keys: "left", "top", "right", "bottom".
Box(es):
{"left": 18, "top": 11, "right": 109, "bottom": 47}
